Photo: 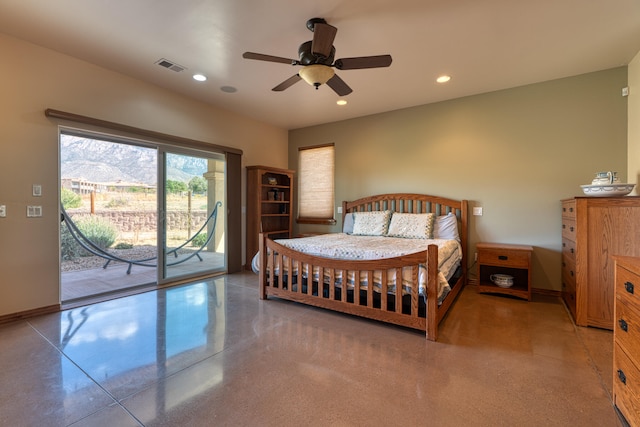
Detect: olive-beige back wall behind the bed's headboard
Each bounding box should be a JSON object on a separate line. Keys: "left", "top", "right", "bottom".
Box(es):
{"left": 289, "top": 67, "right": 627, "bottom": 290}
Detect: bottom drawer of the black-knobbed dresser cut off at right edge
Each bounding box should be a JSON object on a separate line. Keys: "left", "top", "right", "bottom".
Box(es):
{"left": 613, "top": 344, "right": 640, "bottom": 426}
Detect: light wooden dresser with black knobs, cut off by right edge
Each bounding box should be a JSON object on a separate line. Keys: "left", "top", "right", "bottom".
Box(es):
{"left": 613, "top": 257, "right": 640, "bottom": 426}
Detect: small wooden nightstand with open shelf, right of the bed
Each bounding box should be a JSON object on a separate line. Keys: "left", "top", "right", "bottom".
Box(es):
{"left": 476, "top": 243, "right": 533, "bottom": 301}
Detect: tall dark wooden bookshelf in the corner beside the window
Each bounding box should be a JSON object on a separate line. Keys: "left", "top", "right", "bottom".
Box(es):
{"left": 245, "top": 166, "right": 294, "bottom": 270}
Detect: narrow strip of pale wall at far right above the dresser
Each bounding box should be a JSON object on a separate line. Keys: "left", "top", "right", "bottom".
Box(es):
{"left": 627, "top": 52, "right": 640, "bottom": 194}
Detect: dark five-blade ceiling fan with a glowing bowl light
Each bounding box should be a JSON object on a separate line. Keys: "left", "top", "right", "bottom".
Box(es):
{"left": 242, "top": 18, "right": 391, "bottom": 96}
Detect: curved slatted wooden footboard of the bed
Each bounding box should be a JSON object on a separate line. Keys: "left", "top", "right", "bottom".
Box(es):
{"left": 259, "top": 235, "right": 462, "bottom": 341}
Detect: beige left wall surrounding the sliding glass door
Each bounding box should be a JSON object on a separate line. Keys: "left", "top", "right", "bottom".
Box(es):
{"left": 0, "top": 34, "right": 287, "bottom": 315}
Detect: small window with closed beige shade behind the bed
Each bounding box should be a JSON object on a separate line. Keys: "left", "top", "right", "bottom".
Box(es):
{"left": 298, "top": 144, "right": 336, "bottom": 224}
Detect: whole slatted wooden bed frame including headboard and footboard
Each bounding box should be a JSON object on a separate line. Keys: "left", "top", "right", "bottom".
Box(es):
{"left": 259, "top": 193, "right": 467, "bottom": 341}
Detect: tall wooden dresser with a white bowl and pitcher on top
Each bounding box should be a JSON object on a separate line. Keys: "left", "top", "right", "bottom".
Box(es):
{"left": 562, "top": 196, "right": 640, "bottom": 329}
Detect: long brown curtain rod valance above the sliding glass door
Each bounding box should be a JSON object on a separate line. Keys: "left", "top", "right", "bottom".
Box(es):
{"left": 44, "top": 108, "right": 242, "bottom": 155}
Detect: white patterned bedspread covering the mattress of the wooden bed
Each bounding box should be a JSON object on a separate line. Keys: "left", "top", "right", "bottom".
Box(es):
{"left": 252, "top": 233, "right": 462, "bottom": 301}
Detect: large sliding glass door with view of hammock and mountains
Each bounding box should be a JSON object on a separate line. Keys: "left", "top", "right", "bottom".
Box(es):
{"left": 60, "top": 129, "right": 227, "bottom": 303}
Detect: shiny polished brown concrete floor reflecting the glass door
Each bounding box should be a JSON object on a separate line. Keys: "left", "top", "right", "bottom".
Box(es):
{"left": 0, "top": 273, "right": 620, "bottom": 427}
